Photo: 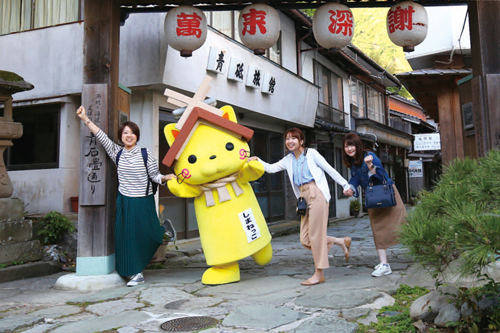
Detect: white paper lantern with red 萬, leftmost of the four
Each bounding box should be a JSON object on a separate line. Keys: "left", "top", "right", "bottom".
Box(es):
{"left": 165, "top": 6, "right": 207, "bottom": 57}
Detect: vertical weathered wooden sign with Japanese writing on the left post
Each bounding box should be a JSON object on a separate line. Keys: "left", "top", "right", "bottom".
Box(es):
{"left": 79, "top": 84, "right": 108, "bottom": 206}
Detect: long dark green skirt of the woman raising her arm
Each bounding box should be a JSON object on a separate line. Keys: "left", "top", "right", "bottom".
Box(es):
{"left": 115, "top": 193, "right": 165, "bottom": 276}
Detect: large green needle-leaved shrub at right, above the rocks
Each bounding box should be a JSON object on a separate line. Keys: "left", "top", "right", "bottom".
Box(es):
{"left": 401, "top": 150, "right": 500, "bottom": 278}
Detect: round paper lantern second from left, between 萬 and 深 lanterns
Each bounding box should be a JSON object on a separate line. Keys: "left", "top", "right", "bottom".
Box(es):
{"left": 238, "top": 4, "right": 280, "bottom": 55}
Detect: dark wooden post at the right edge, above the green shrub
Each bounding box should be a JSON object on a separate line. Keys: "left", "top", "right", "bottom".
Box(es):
{"left": 468, "top": 0, "right": 500, "bottom": 157}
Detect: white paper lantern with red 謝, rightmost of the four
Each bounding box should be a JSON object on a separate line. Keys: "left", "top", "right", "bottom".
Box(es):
{"left": 387, "top": 1, "right": 427, "bottom": 52}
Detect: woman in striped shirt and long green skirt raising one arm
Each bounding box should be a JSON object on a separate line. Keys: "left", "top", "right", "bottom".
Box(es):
{"left": 76, "top": 106, "right": 175, "bottom": 286}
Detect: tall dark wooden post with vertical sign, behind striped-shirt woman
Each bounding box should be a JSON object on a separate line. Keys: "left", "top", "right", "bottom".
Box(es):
{"left": 76, "top": 0, "right": 120, "bottom": 275}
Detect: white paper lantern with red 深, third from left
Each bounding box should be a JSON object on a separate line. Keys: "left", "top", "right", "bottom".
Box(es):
{"left": 313, "top": 2, "right": 354, "bottom": 49}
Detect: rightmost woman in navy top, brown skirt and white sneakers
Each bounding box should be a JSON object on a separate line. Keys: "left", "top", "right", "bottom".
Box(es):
{"left": 343, "top": 133, "right": 406, "bottom": 276}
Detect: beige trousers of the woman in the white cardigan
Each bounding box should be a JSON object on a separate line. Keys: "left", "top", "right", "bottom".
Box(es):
{"left": 300, "top": 181, "right": 330, "bottom": 269}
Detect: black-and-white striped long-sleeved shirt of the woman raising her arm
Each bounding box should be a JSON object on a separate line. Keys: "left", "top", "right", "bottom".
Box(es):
{"left": 96, "top": 130, "right": 163, "bottom": 197}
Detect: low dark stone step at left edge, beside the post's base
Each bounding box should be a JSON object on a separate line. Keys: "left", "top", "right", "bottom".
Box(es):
{"left": 0, "top": 261, "right": 62, "bottom": 283}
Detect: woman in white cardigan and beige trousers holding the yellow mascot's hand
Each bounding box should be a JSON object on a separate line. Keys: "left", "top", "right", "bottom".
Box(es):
{"left": 249, "top": 128, "right": 351, "bottom": 286}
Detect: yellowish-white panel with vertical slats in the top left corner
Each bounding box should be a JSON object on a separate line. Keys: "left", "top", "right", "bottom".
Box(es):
{"left": 0, "top": 0, "right": 80, "bottom": 35}
